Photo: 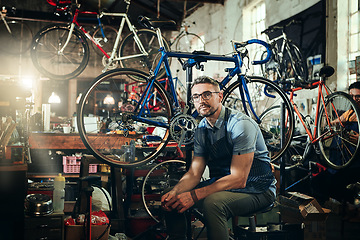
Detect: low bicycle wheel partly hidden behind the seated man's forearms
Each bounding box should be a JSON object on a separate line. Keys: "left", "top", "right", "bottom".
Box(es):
{"left": 141, "top": 160, "right": 186, "bottom": 222}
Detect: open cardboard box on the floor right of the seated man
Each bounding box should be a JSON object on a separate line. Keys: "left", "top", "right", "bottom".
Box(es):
{"left": 279, "top": 192, "right": 331, "bottom": 223}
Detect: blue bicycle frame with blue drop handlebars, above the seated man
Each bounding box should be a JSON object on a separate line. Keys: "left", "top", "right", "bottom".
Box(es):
{"left": 133, "top": 24, "right": 271, "bottom": 128}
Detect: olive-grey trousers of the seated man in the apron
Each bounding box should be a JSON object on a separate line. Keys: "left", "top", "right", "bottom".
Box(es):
{"left": 165, "top": 190, "right": 275, "bottom": 240}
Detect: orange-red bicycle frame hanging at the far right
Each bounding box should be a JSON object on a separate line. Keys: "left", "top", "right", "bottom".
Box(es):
{"left": 290, "top": 80, "right": 343, "bottom": 143}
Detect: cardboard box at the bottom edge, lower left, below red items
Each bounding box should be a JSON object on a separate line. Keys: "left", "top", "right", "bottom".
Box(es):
{"left": 65, "top": 225, "right": 110, "bottom": 240}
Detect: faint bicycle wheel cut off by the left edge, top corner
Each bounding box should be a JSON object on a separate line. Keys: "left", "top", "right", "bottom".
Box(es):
{"left": 0, "top": 21, "right": 33, "bottom": 55}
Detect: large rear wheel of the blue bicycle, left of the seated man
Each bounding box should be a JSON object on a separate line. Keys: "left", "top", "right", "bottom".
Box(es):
{"left": 77, "top": 68, "right": 173, "bottom": 167}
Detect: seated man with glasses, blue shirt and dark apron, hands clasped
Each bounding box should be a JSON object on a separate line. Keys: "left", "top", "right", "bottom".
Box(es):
{"left": 161, "top": 77, "right": 276, "bottom": 240}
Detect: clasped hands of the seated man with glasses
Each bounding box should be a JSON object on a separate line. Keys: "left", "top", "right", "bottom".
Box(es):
{"left": 161, "top": 191, "right": 195, "bottom": 213}
